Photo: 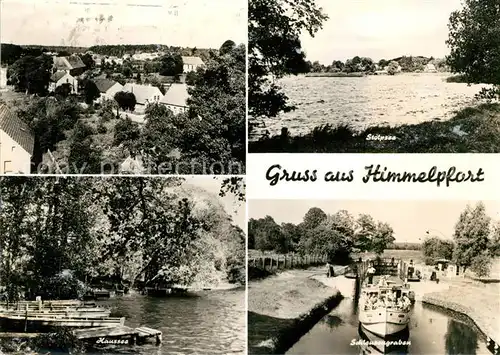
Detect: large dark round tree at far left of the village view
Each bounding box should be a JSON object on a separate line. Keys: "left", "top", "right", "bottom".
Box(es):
{"left": 8, "top": 55, "right": 52, "bottom": 96}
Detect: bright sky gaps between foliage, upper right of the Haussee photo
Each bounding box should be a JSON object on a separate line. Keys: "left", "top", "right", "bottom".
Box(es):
{"left": 185, "top": 175, "right": 246, "bottom": 231}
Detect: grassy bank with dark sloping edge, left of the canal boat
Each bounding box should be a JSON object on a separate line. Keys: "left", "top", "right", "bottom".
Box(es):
{"left": 248, "top": 268, "right": 342, "bottom": 354}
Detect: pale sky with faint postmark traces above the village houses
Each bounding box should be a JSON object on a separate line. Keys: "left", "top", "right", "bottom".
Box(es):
{"left": 0, "top": 0, "right": 247, "bottom": 48}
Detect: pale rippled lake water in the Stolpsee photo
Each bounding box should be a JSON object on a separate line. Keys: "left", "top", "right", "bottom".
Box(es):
{"left": 251, "top": 73, "right": 487, "bottom": 139}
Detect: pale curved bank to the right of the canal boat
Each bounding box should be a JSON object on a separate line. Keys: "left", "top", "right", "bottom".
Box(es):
{"left": 422, "top": 280, "right": 500, "bottom": 344}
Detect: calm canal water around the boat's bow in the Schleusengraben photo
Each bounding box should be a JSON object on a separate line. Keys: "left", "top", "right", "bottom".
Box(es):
{"left": 287, "top": 290, "right": 491, "bottom": 355}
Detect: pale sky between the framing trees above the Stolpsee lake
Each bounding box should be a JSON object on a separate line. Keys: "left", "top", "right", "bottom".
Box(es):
{"left": 301, "top": 0, "right": 462, "bottom": 65}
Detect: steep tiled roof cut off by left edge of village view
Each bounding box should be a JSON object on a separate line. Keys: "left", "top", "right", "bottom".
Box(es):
{"left": 0, "top": 104, "right": 35, "bottom": 155}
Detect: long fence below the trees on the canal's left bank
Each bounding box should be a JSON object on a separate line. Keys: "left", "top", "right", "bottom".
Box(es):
{"left": 248, "top": 254, "right": 327, "bottom": 271}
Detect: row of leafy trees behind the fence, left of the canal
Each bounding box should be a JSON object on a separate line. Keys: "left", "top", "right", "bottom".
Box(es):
{"left": 248, "top": 207, "right": 395, "bottom": 264}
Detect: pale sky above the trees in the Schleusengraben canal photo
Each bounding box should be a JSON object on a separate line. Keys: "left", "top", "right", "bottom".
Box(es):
{"left": 248, "top": 200, "right": 500, "bottom": 243}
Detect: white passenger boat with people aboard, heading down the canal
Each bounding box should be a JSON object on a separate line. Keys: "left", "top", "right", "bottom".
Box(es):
{"left": 359, "top": 276, "right": 414, "bottom": 336}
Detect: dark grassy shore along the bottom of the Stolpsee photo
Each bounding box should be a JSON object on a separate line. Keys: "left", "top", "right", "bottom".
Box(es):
{"left": 248, "top": 103, "right": 500, "bottom": 153}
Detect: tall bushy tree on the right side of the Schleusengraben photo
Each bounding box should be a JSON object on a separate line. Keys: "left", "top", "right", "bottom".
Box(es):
{"left": 453, "top": 202, "right": 491, "bottom": 267}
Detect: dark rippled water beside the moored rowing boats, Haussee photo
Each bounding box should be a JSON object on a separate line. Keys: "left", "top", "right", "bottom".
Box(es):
{"left": 89, "top": 289, "right": 246, "bottom": 355}
